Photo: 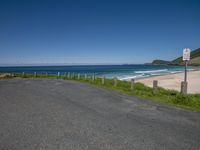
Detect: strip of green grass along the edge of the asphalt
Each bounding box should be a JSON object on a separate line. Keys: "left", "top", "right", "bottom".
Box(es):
{"left": 10, "top": 73, "right": 200, "bottom": 110}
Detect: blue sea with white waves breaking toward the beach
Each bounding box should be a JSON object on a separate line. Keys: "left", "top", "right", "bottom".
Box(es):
{"left": 0, "top": 65, "right": 200, "bottom": 80}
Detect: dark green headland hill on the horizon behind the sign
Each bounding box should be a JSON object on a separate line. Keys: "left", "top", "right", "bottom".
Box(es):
{"left": 152, "top": 48, "right": 200, "bottom": 66}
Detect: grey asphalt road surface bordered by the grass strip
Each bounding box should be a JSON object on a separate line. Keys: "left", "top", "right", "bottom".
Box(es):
{"left": 0, "top": 78, "right": 200, "bottom": 150}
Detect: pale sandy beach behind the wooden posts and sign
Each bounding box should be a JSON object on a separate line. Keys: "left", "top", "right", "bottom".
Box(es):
{"left": 136, "top": 71, "right": 200, "bottom": 93}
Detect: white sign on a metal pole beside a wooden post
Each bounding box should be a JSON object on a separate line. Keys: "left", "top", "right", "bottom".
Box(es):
{"left": 181, "top": 48, "right": 190, "bottom": 94}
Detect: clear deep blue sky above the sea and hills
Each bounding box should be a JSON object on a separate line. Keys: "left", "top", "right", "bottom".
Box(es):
{"left": 0, "top": 0, "right": 200, "bottom": 65}
